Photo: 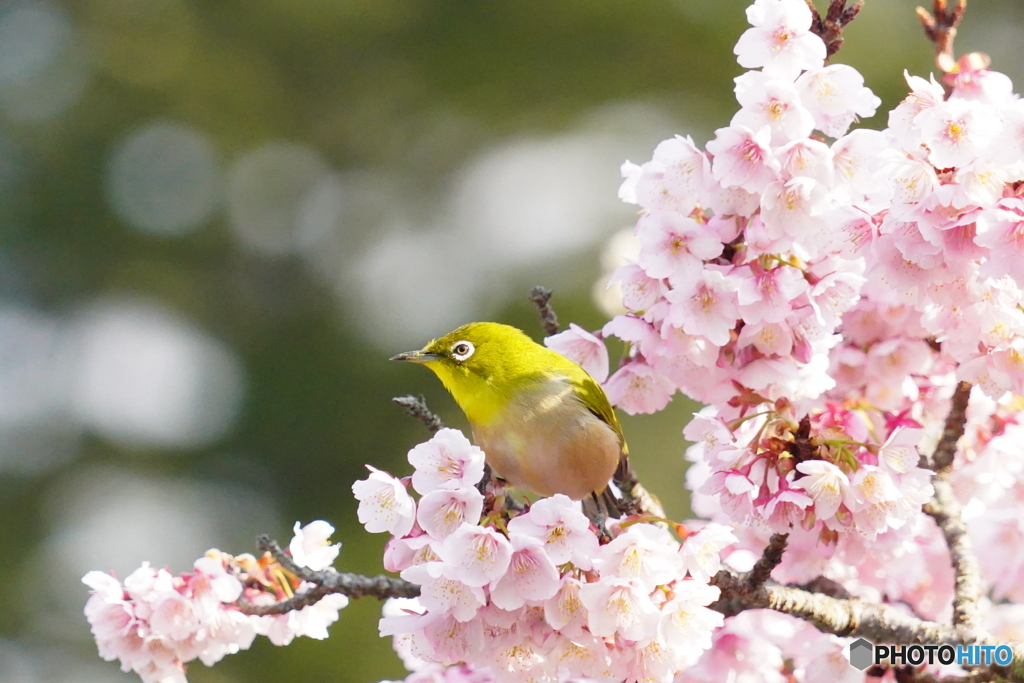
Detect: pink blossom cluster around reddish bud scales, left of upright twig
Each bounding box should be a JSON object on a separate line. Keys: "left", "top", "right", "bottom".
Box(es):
{"left": 683, "top": 404, "right": 932, "bottom": 546}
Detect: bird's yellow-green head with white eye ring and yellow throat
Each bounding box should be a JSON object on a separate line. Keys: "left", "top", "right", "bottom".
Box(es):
{"left": 391, "top": 323, "right": 540, "bottom": 423}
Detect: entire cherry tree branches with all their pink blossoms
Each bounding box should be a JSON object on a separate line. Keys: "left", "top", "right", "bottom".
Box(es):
{"left": 85, "top": 0, "right": 1024, "bottom": 683}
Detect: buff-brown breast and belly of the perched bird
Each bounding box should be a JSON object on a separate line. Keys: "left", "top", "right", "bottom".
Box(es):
{"left": 473, "top": 378, "right": 622, "bottom": 500}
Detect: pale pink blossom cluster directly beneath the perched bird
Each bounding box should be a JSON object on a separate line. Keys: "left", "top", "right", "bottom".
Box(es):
{"left": 352, "top": 429, "right": 735, "bottom": 681}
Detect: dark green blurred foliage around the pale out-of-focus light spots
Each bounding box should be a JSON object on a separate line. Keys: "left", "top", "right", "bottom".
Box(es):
{"left": 8, "top": 0, "right": 1014, "bottom": 683}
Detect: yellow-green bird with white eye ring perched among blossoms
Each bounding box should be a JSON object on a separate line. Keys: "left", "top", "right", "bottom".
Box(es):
{"left": 391, "top": 323, "right": 635, "bottom": 517}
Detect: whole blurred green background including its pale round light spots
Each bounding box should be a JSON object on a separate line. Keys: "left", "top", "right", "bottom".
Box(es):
{"left": 0, "top": 0, "right": 1011, "bottom": 683}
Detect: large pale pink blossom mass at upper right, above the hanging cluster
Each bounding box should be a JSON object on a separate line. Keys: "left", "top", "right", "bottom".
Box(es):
{"left": 554, "top": 0, "right": 1024, "bottom": 417}
